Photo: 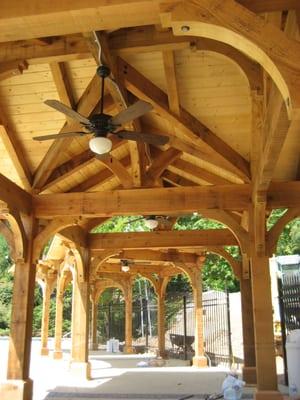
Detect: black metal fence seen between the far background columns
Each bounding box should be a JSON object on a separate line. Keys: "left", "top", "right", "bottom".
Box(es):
{"left": 98, "top": 291, "right": 232, "bottom": 366}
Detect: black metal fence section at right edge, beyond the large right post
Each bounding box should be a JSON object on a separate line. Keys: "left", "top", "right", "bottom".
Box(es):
{"left": 278, "top": 272, "right": 300, "bottom": 384}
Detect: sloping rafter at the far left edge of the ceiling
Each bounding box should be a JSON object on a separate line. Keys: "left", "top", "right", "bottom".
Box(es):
{"left": 0, "top": 109, "right": 32, "bottom": 191}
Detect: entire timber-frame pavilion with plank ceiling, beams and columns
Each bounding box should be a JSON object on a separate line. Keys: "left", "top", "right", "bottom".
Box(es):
{"left": 0, "top": 0, "right": 300, "bottom": 400}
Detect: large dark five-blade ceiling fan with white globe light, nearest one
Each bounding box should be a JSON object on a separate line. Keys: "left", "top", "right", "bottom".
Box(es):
{"left": 33, "top": 65, "right": 169, "bottom": 155}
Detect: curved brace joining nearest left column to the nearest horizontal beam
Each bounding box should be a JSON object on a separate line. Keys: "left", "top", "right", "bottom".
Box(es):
{"left": 33, "top": 217, "right": 78, "bottom": 263}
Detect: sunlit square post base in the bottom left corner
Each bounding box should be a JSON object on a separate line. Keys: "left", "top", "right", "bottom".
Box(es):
{"left": 0, "top": 379, "right": 33, "bottom": 400}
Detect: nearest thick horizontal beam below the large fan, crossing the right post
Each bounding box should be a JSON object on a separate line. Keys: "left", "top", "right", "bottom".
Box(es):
{"left": 33, "top": 182, "right": 300, "bottom": 218}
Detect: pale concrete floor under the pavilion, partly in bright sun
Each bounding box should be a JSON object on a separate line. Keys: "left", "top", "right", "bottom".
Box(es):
{"left": 0, "top": 339, "right": 290, "bottom": 400}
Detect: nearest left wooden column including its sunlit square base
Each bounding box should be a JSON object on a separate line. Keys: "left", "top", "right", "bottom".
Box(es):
{"left": 0, "top": 217, "right": 36, "bottom": 400}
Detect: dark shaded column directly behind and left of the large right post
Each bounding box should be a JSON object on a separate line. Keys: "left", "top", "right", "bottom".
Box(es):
{"left": 240, "top": 277, "right": 256, "bottom": 384}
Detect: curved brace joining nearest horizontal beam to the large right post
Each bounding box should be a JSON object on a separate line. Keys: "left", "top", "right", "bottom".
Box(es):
{"left": 200, "top": 210, "right": 250, "bottom": 254}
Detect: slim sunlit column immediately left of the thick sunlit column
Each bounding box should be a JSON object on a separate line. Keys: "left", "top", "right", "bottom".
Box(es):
{"left": 53, "top": 276, "right": 64, "bottom": 360}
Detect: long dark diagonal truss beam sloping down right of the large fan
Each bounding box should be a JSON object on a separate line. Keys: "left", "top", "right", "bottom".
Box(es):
{"left": 118, "top": 58, "right": 250, "bottom": 180}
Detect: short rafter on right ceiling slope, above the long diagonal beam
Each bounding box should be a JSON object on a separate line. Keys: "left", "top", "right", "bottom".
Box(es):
{"left": 162, "top": 51, "right": 180, "bottom": 115}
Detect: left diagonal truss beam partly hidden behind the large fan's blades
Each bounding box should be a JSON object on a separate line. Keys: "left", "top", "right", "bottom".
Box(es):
{"left": 33, "top": 75, "right": 100, "bottom": 189}
